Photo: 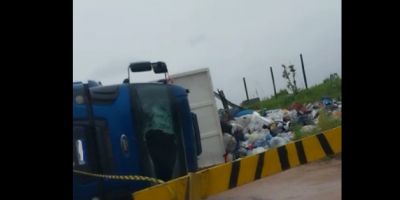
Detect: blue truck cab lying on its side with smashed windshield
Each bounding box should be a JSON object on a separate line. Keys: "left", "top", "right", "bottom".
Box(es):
{"left": 73, "top": 61, "right": 201, "bottom": 200}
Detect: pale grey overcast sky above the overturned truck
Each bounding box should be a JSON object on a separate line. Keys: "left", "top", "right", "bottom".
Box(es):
{"left": 73, "top": 0, "right": 341, "bottom": 104}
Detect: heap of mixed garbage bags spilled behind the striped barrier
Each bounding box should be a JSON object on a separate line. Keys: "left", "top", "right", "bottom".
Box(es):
{"left": 220, "top": 97, "right": 342, "bottom": 161}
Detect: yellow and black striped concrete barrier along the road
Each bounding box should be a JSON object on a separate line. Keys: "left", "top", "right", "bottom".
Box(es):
{"left": 132, "top": 127, "right": 342, "bottom": 200}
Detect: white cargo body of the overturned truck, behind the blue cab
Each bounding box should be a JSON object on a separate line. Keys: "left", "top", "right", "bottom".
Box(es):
{"left": 170, "top": 68, "right": 225, "bottom": 168}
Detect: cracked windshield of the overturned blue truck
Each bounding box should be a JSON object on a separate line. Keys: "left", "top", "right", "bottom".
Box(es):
{"left": 133, "top": 84, "right": 186, "bottom": 180}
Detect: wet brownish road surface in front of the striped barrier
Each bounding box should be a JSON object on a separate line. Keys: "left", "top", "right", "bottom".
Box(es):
{"left": 207, "top": 156, "right": 342, "bottom": 200}
